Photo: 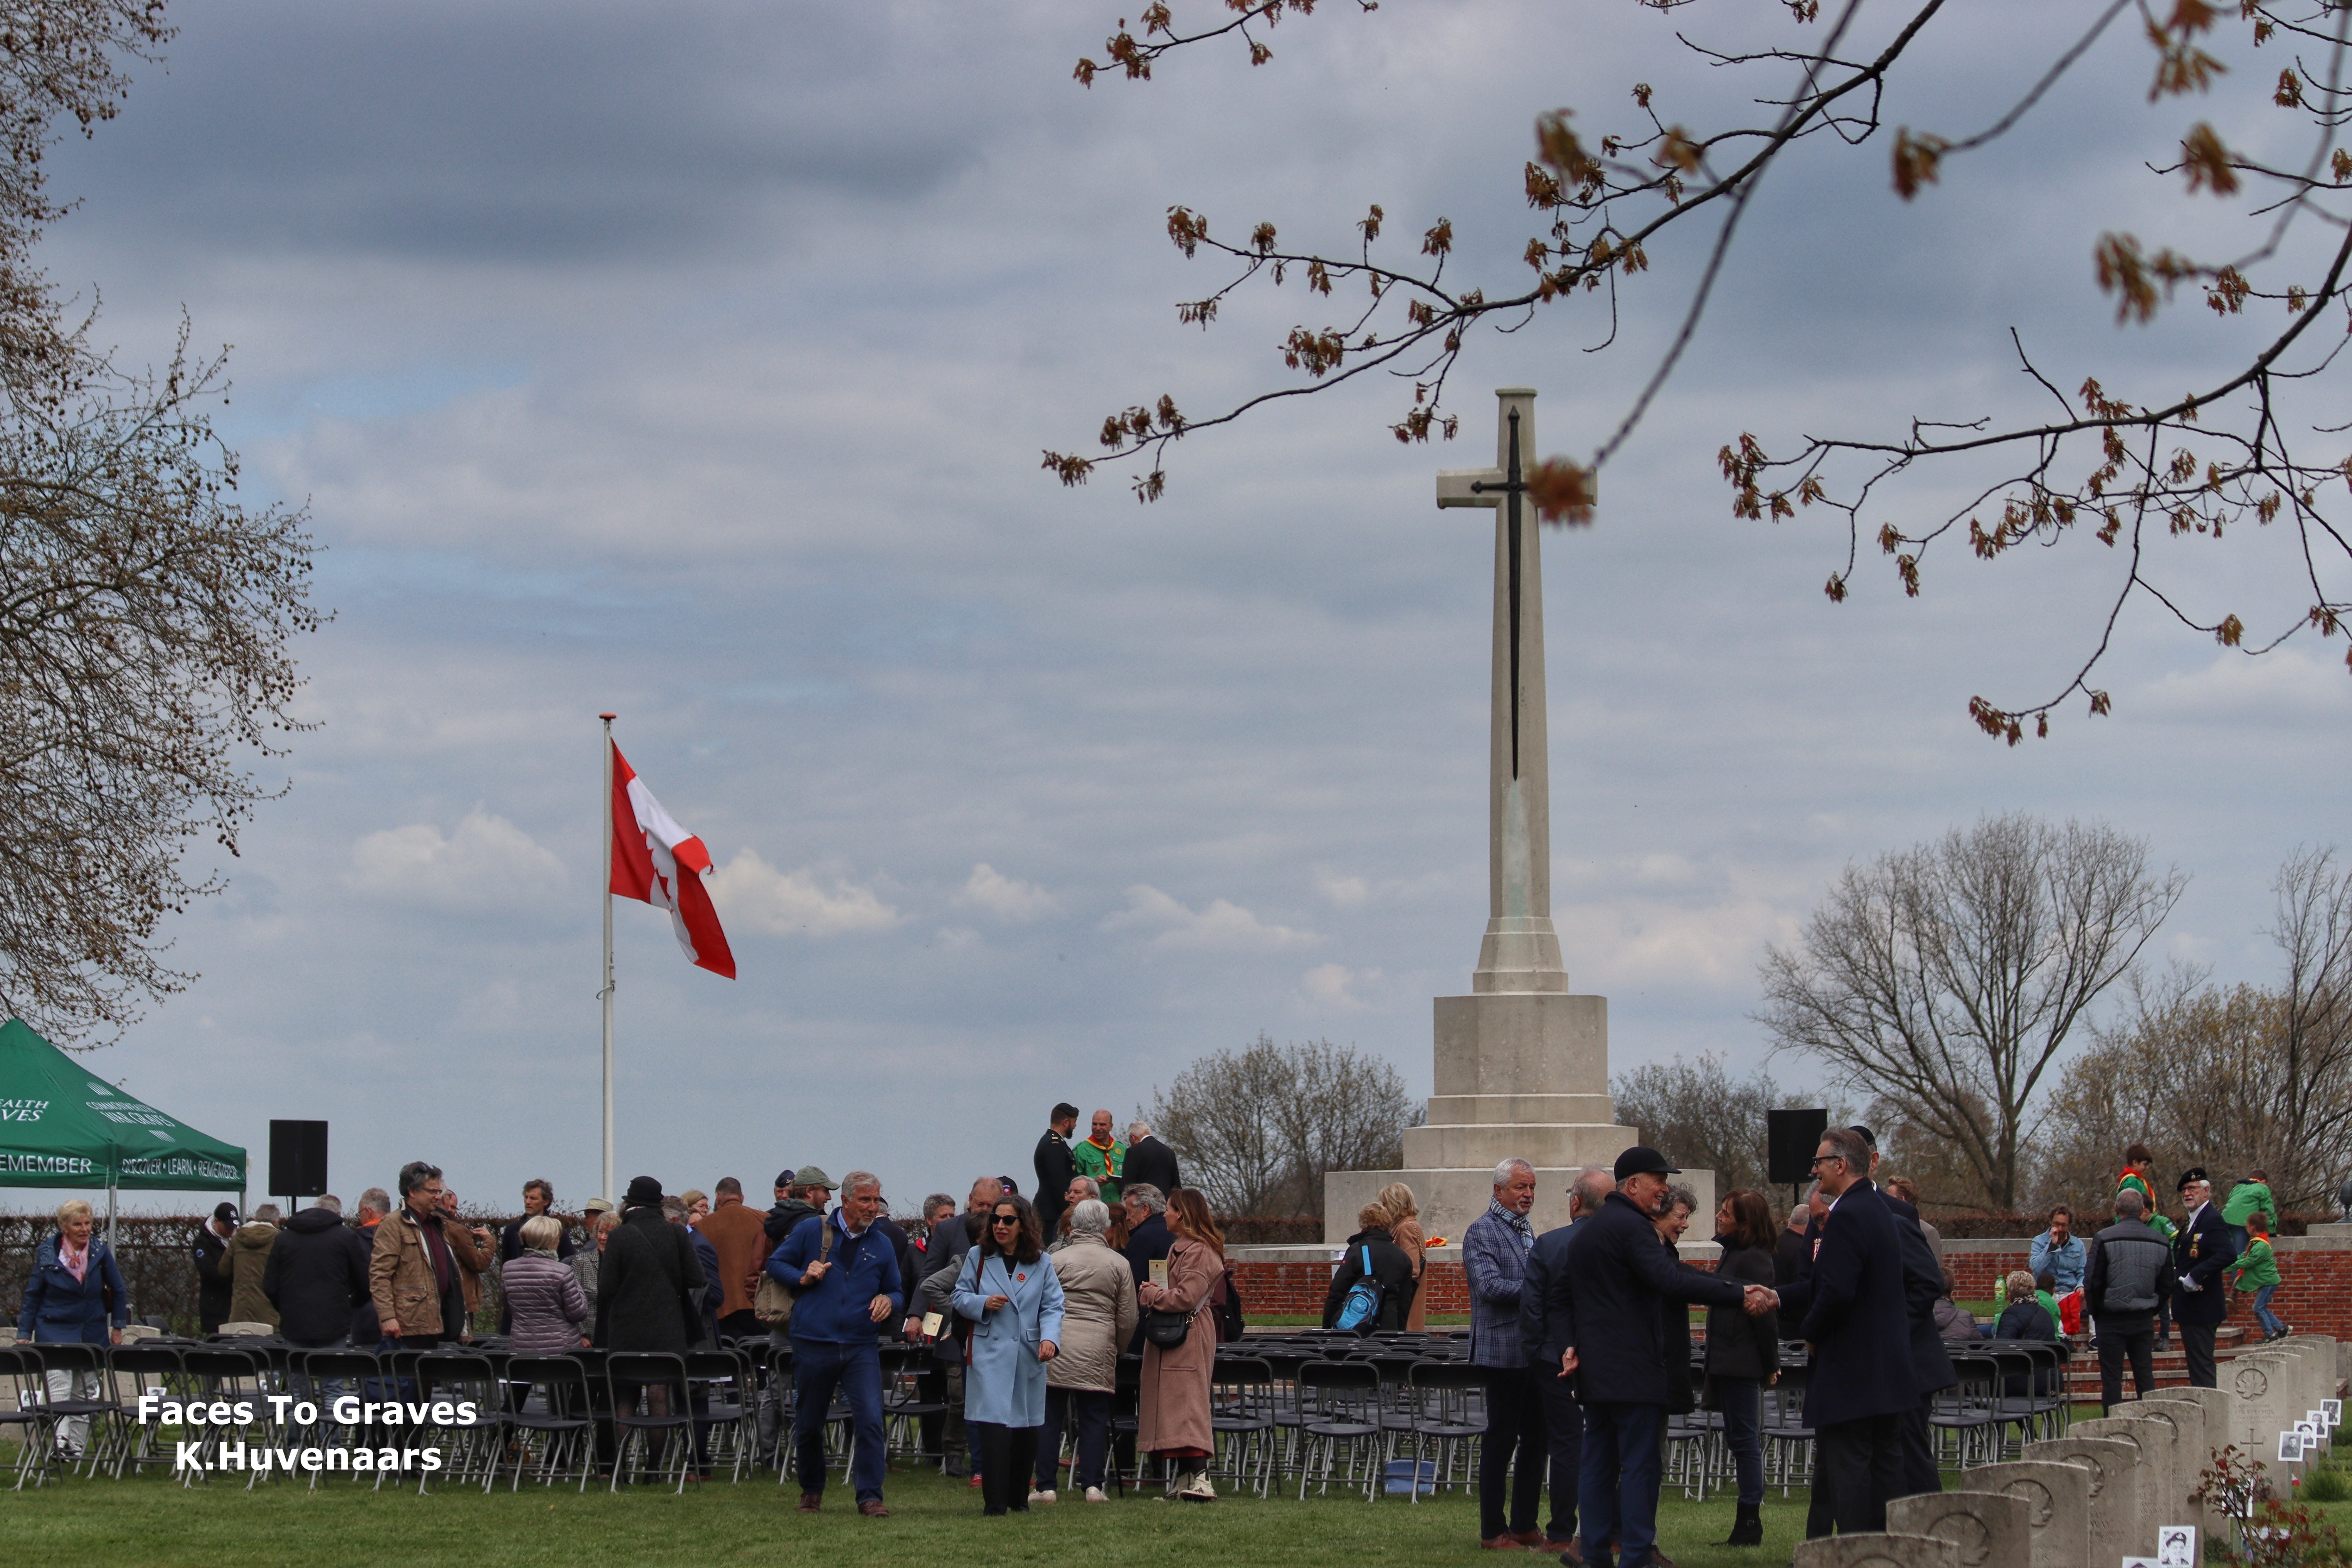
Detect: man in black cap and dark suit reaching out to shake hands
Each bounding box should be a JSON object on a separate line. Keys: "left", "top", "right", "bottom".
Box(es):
{"left": 1562, "top": 1145, "right": 1778, "bottom": 1568}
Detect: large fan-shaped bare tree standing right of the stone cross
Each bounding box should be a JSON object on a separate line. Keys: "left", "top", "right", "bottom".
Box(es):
{"left": 1757, "top": 813, "right": 2187, "bottom": 1210}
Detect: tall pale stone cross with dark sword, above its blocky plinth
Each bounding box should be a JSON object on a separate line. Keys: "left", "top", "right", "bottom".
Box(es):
{"left": 1437, "top": 386, "right": 1569, "bottom": 992}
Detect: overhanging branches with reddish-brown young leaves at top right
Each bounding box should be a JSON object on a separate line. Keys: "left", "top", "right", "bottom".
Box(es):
{"left": 1044, "top": 0, "right": 2352, "bottom": 745}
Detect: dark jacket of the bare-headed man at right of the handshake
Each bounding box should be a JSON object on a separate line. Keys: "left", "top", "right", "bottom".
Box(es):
{"left": 1780, "top": 1178, "right": 1924, "bottom": 1429}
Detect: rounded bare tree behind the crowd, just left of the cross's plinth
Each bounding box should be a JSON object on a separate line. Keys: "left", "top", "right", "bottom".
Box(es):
{"left": 1143, "top": 1032, "right": 1423, "bottom": 1215}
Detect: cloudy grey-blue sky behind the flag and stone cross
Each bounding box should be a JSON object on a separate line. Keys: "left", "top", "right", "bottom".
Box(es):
{"left": 9, "top": 0, "right": 2352, "bottom": 1206}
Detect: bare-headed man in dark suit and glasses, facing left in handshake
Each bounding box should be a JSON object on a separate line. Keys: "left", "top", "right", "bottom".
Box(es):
{"left": 1780, "top": 1126, "right": 1940, "bottom": 1535}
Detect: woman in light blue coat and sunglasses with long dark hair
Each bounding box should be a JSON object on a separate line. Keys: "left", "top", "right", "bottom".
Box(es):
{"left": 953, "top": 1196, "right": 1061, "bottom": 1514}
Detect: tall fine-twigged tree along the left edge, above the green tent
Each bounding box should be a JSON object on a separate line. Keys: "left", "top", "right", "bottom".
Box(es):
{"left": 0, "top": 0, "right": 320, "bottom": 1044}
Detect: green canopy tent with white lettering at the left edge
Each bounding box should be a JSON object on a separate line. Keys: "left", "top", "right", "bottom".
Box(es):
{"left": 0, "top": 1018, "right": 245, "bottom": 1236}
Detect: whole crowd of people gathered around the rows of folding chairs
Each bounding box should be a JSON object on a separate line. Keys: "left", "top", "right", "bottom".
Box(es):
{"left": 0, "top": 1105, "right": 2286, "bottom": 1542}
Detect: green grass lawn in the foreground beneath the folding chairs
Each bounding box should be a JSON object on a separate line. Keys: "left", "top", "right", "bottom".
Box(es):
{"left": 0, "top": 1469, "right": 1863, "bottom": 1568}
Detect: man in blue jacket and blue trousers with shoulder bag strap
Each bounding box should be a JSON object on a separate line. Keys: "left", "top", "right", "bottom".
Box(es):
{"left": 767, "top": 1171, "right": 906, "bottom": 1519}
